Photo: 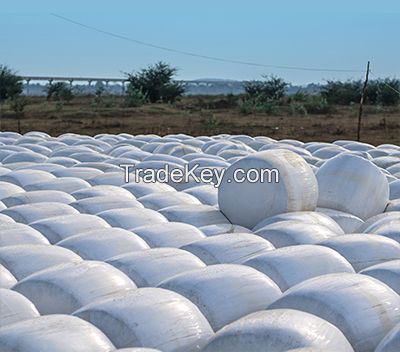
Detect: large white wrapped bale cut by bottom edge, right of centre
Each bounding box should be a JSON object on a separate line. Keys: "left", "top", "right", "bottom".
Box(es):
{"left": 203, "top": 309, "right": 353, "bottom": 352}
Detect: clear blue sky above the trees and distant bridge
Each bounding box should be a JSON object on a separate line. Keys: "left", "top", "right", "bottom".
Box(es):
{"left": 0, "top": 0, "right": 400, "bottom": 84}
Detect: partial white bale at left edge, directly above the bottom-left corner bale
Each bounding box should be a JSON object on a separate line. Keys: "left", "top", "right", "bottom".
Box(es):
{"left": 0, "top": 288, "right": 40, "bottom": 328}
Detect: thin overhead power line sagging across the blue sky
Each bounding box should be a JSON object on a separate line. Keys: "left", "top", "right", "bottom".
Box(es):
{"left": 50, "top": 13, "right": 365, "bottom": 73}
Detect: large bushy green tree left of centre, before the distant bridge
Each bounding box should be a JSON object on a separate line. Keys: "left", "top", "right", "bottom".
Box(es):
{"left": 128, "top": 62, "right": 185, "bottom": 103}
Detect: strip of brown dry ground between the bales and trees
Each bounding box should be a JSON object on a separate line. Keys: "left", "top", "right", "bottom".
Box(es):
{"left": 0, "top": 97, "right": 400, "bottom": 145}
